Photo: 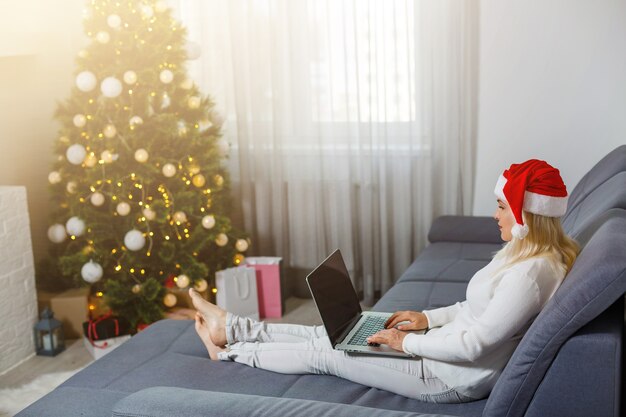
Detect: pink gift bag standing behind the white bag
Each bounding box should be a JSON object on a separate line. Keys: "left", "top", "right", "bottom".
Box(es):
{"left": 246, "top": 256, "right": 283, "bottom": 318}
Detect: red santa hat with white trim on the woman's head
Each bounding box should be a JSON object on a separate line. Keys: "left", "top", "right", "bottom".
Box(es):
{"left": 494, "top": 159, "right": 567, "bottom": 239}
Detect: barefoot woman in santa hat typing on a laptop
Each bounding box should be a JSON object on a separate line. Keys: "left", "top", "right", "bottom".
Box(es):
{"left": 190, "top": 160, "right": 578, "bottom": 403}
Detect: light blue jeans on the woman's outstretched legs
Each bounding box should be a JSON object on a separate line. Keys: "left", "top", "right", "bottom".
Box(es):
{"left": 218, "top": 313, "right": 473, "bottom": 403}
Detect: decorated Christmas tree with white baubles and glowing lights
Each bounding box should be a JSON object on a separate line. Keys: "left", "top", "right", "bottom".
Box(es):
{"left": 42, "top": 0, "right": 249, "bottom": 326}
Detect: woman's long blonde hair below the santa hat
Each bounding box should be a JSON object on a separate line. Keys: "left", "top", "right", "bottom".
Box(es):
{"left": 496, "top": 211, "right": 580, "bottom": 273}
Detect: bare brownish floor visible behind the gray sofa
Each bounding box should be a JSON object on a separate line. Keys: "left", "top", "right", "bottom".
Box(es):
{"left": 0, "top": 297, "right": 321, "bottom": 389}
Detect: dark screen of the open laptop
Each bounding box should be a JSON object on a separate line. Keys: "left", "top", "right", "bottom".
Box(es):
{"left": 306, "top": 249, "right": 361, "bottom": 346}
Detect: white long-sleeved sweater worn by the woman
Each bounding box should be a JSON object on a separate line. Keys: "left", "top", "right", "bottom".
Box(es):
{"left": 402, "top": 257, "right": 565, "bottom": 398}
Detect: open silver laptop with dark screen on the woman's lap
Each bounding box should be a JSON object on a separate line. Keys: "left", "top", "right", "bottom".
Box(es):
{"left": 306, "top": 249, "right": 424, "bottom": 357}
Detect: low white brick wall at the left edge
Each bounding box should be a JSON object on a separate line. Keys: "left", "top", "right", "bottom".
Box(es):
{"left": 0, "top": 186, "right": 38, "bottom": 374}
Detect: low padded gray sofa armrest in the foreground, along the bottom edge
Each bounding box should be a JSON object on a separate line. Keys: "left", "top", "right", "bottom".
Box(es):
{"left": 112, "top": 387, "right": 458, "bottom": 417}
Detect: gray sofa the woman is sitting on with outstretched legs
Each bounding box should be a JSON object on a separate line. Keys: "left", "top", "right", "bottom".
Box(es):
{"left": 19, "top": 146, "right": 626, "bottom": 417}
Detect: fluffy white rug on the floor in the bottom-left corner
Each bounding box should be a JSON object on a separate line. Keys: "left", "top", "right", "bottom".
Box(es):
{"left": 0, "top": 368, "right": 82, "bottom": 417}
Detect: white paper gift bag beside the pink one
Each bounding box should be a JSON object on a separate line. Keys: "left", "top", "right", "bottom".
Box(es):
{"left": 215, "top": 266, "right": 259, "bottom": 320}
